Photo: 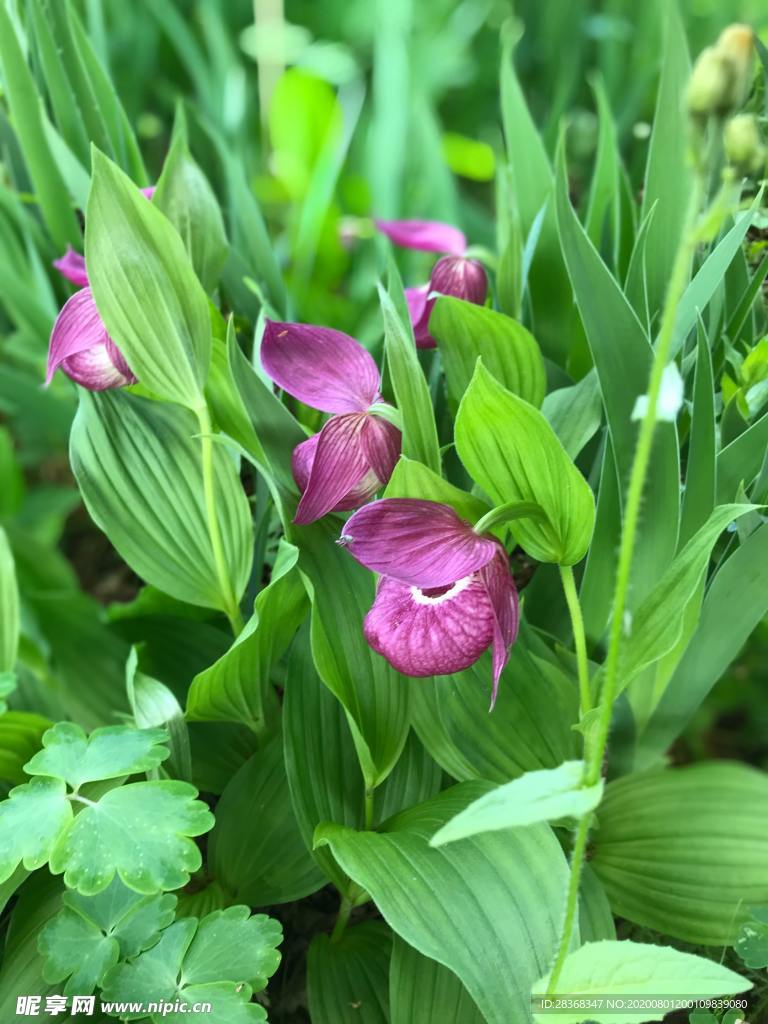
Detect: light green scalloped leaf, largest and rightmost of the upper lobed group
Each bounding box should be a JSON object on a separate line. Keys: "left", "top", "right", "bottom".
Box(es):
{"left": 49, "top": 780, "right": 213, "bottom": 895}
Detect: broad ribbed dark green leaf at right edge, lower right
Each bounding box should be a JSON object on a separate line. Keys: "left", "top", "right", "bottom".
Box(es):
{"left": 593, "top": 762, "right": 768, "bottom": 942}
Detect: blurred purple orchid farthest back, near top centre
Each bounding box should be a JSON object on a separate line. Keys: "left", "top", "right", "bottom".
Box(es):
{"left": 376, "top": 220, "right": 488, "bottom": 348}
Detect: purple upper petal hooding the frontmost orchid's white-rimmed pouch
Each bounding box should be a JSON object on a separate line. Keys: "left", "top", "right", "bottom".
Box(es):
{"left": 341, "top": 498, "right": 498, "bottom": 588}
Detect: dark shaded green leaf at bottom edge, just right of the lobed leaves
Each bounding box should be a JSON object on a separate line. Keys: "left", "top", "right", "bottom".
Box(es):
{"left": 307, "top": 921, "right": 392, "bottom": 1024}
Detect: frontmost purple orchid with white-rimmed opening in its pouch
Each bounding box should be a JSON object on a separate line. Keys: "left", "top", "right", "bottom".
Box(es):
{"left": 340, "top": 498, "right": 520, "bottom": 709}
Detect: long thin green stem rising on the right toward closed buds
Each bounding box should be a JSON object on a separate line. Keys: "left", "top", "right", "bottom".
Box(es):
{"left": 547, "top": 174, "right": 717, "bottom": 994}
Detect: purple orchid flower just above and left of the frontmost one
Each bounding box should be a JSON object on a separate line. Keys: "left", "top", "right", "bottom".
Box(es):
{"left": 261, "top": 321, "right": 401, "bottom": 524}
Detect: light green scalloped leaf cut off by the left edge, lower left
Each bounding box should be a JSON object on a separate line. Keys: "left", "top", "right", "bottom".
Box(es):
{"left": 0, "top": 778, "right": 72, "bottom": 882}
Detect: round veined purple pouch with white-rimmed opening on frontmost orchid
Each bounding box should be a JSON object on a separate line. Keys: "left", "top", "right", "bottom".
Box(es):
{"left": 364, "top": 573, "right": 496, "bottom": 676}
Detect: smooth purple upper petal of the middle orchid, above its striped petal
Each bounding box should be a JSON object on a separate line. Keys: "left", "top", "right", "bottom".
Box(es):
{"left": 261, "top": 321, "right": 381, "bottom": 413}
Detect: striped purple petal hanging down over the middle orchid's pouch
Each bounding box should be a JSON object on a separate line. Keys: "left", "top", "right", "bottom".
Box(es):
{"left": 294, "top": 413, "right": 370, "bottom": 524}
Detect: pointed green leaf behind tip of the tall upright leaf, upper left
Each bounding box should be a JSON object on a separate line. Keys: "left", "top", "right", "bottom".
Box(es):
{"left": 153, "top": 106, "right": 228, "bottom": 293}
